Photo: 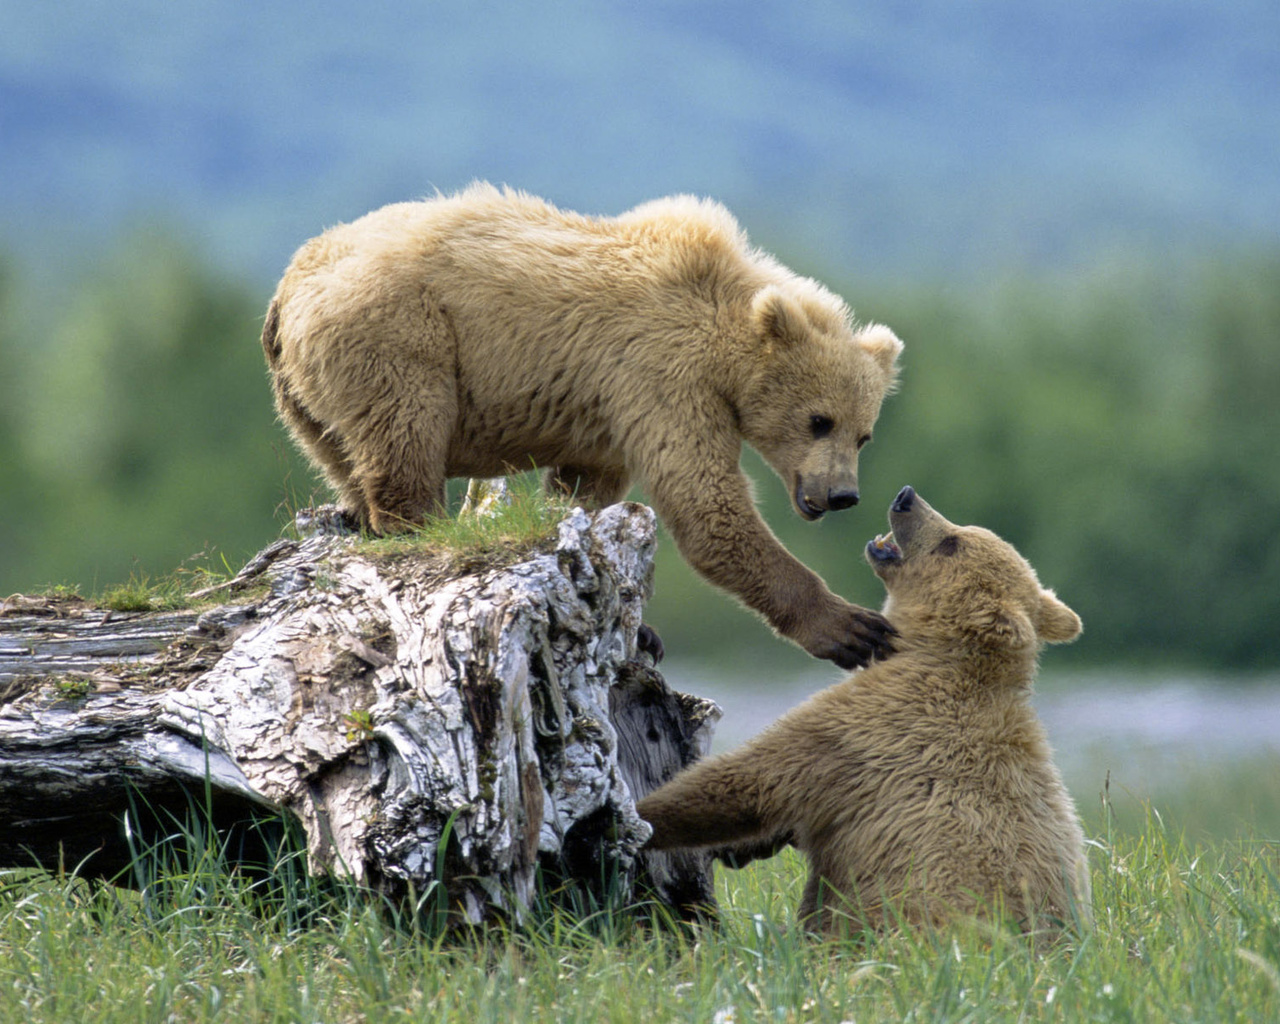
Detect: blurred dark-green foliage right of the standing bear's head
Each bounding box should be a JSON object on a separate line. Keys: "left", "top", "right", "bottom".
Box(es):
{"left": 649, "top": 255, "right": 1280, "bottom": 667}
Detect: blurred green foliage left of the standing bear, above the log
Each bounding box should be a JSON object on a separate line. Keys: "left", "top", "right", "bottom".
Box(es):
{"left": 0, "top": 230, "right": 317, "bottom": 593}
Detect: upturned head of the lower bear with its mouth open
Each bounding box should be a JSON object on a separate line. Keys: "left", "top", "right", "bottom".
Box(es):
{"left": 867, "top": 488, "right": 1080, "bottom": 648}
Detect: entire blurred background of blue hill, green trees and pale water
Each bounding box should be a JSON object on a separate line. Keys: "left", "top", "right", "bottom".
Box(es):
{"left": 0, "top": 0, "right": 1280, "bottom": 835}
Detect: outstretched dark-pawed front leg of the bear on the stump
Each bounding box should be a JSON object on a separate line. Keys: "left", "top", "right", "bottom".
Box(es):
{"left": 650, "top": 467, "right": 893, "bottom": 668}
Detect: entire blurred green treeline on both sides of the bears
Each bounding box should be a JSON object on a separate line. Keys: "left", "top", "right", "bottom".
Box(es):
{"left": 0, "top": 233, "right": 1280, "bottom": 668}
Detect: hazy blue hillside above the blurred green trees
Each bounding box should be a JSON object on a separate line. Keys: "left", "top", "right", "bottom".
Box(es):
{"left": 0, "top": 0, "right": 1280, "bottom": 288}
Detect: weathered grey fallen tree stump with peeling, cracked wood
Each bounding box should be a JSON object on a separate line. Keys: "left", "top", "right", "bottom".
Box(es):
{"left": 0, "top": 503, "right": 719, "bottom": 922}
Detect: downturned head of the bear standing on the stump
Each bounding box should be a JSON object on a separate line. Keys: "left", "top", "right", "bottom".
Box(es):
{"left": 737, "top": 284, "right": 902, "bottom": 520}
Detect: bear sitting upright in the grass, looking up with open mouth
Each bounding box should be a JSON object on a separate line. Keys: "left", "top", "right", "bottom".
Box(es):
{"left": 636, "top": 488, "right": 1092, "bottom": 936}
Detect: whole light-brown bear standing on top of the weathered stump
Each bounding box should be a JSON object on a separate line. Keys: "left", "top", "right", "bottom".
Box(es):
{"left": 262, "top": 183, "right": 902, "bottom": 668}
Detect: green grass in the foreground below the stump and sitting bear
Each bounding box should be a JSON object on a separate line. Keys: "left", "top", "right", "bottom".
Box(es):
{"left": 0, "top": 798, "right": 1280, "bottom": 1024}
